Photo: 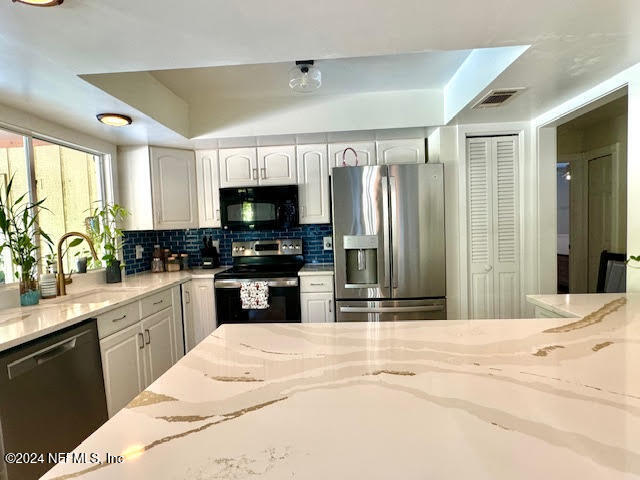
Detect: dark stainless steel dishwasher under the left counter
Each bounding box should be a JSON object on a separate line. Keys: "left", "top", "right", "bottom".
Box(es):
{"left": 0, "top": 320, "right": 107, "bottom": 480}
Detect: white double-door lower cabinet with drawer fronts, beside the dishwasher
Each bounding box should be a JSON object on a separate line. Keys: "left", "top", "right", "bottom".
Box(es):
{"left": 97, "top": 289, "right": 182, "bottom": 417}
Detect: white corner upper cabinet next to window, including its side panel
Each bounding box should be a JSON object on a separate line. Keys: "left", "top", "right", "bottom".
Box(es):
{"left": 118, "top": 146, "right": 198, "bottom": 230}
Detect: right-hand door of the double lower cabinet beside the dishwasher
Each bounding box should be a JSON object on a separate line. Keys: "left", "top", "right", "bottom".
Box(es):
{"left": 141, "top": 308, "right": 176, "bottom": 386}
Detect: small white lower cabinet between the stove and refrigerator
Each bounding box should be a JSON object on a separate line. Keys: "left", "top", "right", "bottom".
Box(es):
{"left": 300, "top": 275, "right": 335, "bottom": 323}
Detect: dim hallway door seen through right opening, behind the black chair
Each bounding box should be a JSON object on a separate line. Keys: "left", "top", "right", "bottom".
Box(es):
{"left": 588, "top": 155, "right": 613, "bottom": 293}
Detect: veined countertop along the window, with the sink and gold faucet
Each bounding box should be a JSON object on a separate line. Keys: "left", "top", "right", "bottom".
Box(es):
{"left": 0, "top": 267, "right": 229, "bottom": 352}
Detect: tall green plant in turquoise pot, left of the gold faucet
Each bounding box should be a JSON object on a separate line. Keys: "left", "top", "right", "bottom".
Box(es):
{"left": 0, "top": 177, "right": 52, "bottom": 305}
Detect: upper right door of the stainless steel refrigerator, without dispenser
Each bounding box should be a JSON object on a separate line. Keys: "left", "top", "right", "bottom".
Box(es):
{"left": 388, "top": 163, "right": 446, "bottom": 298}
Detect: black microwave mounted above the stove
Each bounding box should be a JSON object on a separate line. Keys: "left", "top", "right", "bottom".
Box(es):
{"left": 220, "top": 185, "right": 298, "bottom": 230}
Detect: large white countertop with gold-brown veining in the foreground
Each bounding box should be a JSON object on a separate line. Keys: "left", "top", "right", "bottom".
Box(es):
{"left": 43, "top": 295, "right": 640, "bottom": 480}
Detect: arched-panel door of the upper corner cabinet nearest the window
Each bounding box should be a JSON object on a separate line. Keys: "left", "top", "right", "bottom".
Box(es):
{"left": 151, "top": 147, "right": 198, "bottom": 229}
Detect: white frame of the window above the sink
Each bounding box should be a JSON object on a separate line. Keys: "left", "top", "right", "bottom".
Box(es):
{"left": 0, "top": 122, "right": 113, "bottom": 284}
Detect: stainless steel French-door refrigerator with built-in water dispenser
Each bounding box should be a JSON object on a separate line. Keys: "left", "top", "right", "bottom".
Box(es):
{"left": 331, "top": 164, "right": 446, "bottom": 322}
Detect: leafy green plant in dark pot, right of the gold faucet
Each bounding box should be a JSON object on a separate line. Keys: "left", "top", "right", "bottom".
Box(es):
{"left": 86, "top": 203, "right": 129, "bottom": 283}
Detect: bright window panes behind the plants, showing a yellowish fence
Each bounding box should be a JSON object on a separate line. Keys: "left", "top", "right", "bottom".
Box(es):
{"left": 0, "top": 130, "right": 104, "bottom": 282}
